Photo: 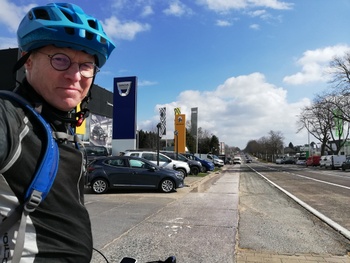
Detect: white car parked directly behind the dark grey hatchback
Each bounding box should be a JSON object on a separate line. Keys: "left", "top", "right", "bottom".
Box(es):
{"left": 124, "top": 150, "right": 190, "bottom": 178}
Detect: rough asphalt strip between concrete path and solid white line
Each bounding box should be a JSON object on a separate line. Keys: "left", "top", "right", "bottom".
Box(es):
{"left": 238, "top": 167, "right": 350, "bottom": 255}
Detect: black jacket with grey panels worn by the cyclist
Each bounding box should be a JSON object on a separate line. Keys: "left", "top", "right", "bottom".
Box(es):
{"left": 0, "top": 80, "right": 92, "bottom": 263}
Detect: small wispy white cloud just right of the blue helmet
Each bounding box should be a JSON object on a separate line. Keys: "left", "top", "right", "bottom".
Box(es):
{"left": 102, "top": 16, "right": 151, "bottom": 40}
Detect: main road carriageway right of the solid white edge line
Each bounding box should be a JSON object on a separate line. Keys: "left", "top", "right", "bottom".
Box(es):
{"left": 251, "top": 161, "right": 350, "bottom": 233}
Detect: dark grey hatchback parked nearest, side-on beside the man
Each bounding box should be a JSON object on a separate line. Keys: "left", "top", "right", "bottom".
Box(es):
{"left": 88, "top": 156, "right": 184, "bottom": 194}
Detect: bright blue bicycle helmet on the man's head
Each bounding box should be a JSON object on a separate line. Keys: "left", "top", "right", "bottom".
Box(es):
{"left": 17, "top": 3, "right": 115, "bottom": 67}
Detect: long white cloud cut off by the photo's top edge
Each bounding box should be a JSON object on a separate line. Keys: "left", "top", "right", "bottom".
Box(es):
{"left": 197, "top": 0, "right": 293, "bottom": 12}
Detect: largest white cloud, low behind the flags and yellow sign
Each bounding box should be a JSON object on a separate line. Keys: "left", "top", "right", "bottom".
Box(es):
{"left": 140, "top": 73, "right": 311, "bottom": 149}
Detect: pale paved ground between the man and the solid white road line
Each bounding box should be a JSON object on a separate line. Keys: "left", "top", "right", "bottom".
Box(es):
{"left": 85, "top": 164, "right": 350, "bottom": 263}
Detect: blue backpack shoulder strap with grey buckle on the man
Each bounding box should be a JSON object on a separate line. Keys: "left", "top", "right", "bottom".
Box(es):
{"left": 0, "top": 90, "right": 59, "bottom": 263}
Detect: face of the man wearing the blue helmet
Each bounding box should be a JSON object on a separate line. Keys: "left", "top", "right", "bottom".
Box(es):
{"left": 25, "top": 46, "right": 95, "bottom": 111}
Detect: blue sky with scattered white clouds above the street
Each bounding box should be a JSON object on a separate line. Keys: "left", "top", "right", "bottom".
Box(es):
{"left": 0, "top": 0, "right": 350, "bottom": 149}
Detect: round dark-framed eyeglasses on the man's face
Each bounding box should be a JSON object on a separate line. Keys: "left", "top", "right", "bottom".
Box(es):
{"left": 37, "top": 51, "right": 100, "bottom": 78}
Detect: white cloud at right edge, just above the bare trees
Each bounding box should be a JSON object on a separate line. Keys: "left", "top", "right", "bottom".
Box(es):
{"left": 283, "top": 45, "right": 350, "bottom": 85}
